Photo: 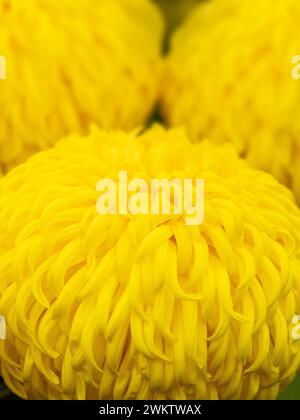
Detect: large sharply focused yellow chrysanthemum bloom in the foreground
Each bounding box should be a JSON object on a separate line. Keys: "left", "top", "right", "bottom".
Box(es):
{"left": 0, "top": 126, "right": 300, "bottom": 399}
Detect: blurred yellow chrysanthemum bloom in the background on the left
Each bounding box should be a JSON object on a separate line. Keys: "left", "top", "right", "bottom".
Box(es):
{"left": 0, "top": 0, "right": 163, "bottom": 170}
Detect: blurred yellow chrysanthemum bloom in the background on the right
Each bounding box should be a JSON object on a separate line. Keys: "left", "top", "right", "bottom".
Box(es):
{"left": 162, "top": 0, "right": 300, "bottom": 200}
